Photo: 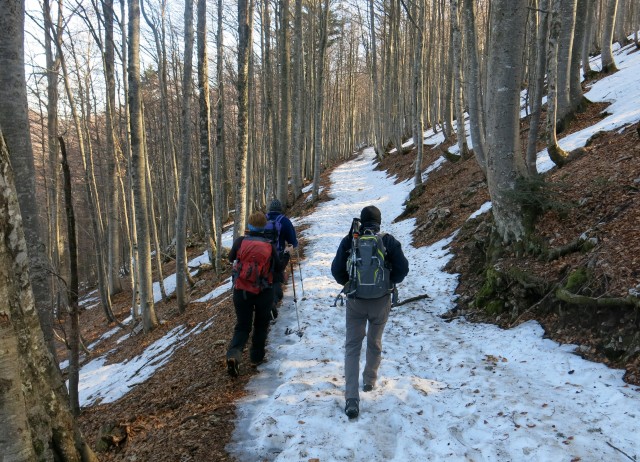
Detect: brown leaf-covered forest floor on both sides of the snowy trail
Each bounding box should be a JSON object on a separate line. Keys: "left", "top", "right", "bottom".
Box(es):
{"left": 67, "top": 100, "right": 640, "bottom": 461}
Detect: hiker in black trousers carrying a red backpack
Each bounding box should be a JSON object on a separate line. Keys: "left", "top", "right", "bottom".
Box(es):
{"left": 227, "top": 212, "right": 292, "bottom": 377}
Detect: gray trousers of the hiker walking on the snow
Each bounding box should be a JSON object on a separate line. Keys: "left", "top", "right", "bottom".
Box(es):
{"left": 344, "top": 295, "right": 391, "bottom": 399}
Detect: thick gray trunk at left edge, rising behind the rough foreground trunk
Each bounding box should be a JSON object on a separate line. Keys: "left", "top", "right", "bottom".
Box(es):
{"left": 0, "top": 0, "right": 54, "bottom": 358}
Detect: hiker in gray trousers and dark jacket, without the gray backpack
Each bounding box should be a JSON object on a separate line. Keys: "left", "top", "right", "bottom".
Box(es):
{"left": 331, "top": 205, "right": 409, "bottom": 419}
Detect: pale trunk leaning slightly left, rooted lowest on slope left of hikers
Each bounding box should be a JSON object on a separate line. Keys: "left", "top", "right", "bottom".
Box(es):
{"left": 128, "top": 0, "right": 158, "bottom": 332}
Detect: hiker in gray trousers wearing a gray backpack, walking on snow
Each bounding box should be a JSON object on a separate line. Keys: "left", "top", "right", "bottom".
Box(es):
{"left": 331, "top": 205, "right": 409, "bottom": 419}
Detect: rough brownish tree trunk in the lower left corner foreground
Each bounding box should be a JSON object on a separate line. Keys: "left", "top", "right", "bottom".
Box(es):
{"left": 0, "top": 125, "right": 98, "bottom": 462}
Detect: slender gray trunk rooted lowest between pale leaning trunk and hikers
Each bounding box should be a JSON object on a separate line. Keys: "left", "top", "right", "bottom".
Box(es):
{"left": 176, "top": 0, "right": 193, "bottom": 313}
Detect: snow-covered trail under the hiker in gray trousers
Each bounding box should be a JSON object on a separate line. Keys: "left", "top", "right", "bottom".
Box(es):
{"left": 229, "top": 150, "right": 640, "bottom": 462}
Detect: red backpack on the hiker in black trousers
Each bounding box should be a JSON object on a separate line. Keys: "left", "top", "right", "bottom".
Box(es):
{"left": 233, "top": 236, "right": 273, "bottom": 294}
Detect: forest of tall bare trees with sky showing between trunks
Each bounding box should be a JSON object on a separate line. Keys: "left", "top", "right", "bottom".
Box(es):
{"left": 0, "top": 0, "right": 640, "bottom": 454}
